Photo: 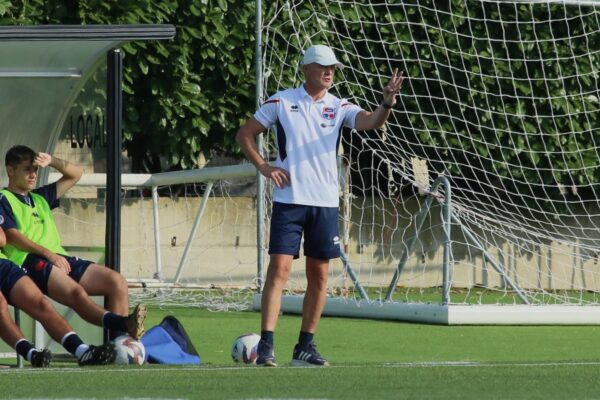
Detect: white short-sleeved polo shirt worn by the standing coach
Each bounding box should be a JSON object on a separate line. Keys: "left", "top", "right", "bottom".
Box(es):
{"left": 254, "top": 86, "right": 362, "bottom": 207}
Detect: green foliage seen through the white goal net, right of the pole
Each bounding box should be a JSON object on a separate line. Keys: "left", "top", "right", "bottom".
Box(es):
{"left": 266, "top": 0, "right": 600, "bottom": 200}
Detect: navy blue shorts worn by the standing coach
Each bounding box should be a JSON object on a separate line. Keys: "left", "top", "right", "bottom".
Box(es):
{"left": 269, "top": 202, "right": 340, "bottom": 260}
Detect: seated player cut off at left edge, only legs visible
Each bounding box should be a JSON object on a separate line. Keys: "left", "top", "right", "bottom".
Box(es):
{"left": 0, "top": 229, "right": 115, "bottom": 368}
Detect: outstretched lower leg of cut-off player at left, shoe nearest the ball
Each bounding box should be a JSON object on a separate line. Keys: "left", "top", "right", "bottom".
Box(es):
{"left": 9, "top": 276, "right": 115, "bottom": 365}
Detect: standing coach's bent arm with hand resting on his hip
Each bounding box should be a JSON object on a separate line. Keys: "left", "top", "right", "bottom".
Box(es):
{"left": 235, "top": 117, "right": 290, "bottom": 188}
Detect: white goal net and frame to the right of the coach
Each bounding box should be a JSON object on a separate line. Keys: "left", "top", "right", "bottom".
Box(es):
{"left": 262, "top": 0, "right": 600, "bottom": 323}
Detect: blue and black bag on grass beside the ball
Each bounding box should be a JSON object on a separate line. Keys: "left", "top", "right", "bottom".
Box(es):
{"left": 141, "top": 315, "right": 201, "bottom": 364}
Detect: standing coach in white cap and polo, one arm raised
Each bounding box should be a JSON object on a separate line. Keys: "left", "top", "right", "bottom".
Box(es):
{"left": 236, "top": 45, "right": 404, "bottom": 367}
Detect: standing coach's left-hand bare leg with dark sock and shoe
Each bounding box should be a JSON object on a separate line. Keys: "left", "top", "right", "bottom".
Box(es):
{"left": 256, "top": 254, "right": 294, "bottom": 367}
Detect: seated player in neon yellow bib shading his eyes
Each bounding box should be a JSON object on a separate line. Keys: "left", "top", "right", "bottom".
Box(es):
{"left": 0, "top": 146, "right": 146, "bottom": 339}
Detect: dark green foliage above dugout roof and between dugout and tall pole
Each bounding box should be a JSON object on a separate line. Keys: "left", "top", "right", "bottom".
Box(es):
{"left": 0, "top": 0, "right": 255, "bottom": 172}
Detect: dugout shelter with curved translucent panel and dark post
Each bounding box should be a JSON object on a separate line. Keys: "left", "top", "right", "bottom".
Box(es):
{"left": 0, "top": 25, "right": 175, "bottom": 364}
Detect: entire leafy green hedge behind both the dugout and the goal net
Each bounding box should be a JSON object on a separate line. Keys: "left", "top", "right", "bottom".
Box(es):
{"left": 0, "top": 0, "right": 600, "bottom": 199}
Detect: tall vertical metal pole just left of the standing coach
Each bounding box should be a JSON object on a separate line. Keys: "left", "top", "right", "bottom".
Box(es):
{"left": 254, "top": 0, "right": 265, "bottom": 292}
